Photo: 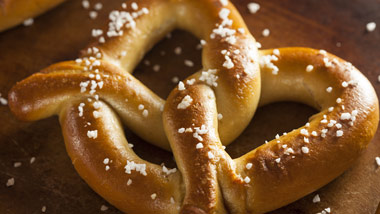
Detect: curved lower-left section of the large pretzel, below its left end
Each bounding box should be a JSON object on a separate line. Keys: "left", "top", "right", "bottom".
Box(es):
{"left": 59, "top": 99, "right": 183, "bottom": 214}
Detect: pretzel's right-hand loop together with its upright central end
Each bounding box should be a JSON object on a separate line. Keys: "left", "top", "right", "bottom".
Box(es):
{"left": 163, "top": 48, "right": 379, "bottom": 213}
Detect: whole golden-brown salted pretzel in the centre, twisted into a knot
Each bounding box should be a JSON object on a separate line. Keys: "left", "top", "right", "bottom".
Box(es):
{"left": 9, "top": 0, "right": 379, "bottom": 214}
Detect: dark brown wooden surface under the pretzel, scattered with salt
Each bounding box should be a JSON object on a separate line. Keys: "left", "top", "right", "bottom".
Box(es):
{"left": 0, "top": 0, "right": 380, "bottom": 214}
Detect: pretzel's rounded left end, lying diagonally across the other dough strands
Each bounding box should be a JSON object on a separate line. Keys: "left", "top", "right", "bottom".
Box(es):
{"left": 9, "top": 61, "right": 170, "bottom": 150}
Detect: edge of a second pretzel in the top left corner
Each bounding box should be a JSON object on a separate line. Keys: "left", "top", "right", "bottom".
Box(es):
{"left": 0, "top": 0, "right": 64, "bottom": 32}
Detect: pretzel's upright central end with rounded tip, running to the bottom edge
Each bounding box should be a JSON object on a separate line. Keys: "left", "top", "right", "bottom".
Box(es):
{"left": 164, "top": 84, "right": 226, "bottom": 213}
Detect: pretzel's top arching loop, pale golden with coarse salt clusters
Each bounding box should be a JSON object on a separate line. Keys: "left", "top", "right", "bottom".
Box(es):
{"left": 85, "top": 0, "right": 260, "bottom": 149}
